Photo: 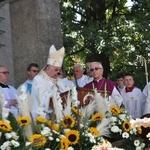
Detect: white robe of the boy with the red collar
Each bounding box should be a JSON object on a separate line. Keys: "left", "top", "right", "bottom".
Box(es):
{"left": 121, "top": 87, "right": 143, "bottom": 118}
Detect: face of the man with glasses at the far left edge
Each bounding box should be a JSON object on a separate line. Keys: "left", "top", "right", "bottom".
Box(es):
{"left": 0, "top": 67, "right": 9, "bottom": 84}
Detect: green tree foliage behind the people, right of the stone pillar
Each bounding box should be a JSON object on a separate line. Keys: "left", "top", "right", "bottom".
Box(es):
{"left": 59, "top": 0, "right": 150, "bottom": 88}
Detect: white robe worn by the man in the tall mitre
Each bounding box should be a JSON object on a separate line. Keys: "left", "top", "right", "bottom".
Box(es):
{"left": 31, "top": 71, "right": 70, "bottom": 118}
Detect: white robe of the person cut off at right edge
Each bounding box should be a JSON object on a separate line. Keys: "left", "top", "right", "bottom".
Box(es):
{"left": 142, "top": 82, "right": 150, "bottom": 115}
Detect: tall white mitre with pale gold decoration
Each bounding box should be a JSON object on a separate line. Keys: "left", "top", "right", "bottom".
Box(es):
{"left": 47, "top": 45, "right": 65, "bottom": 67}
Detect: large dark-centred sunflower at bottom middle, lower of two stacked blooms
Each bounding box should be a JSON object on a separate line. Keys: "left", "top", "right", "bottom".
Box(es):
{"left": 65, "top": 130, "right": 80, "bottom": 145}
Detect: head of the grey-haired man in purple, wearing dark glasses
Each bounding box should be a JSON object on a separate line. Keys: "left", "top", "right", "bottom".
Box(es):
{"left": 90, "top": 63, "right": 103, "bottom": 80}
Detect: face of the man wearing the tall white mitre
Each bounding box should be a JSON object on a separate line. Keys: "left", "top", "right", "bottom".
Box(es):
{"left": 46, "top": 66, "right": 61, "bottom": 79}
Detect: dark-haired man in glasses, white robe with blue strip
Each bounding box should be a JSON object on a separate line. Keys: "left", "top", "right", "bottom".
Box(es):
{"left": 18, "top": 63, "right": 39, "bottom": 94}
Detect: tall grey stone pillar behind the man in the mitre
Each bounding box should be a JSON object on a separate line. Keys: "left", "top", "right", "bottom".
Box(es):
{"left": 0, "top": 0, "right": 63, "bottom": 87}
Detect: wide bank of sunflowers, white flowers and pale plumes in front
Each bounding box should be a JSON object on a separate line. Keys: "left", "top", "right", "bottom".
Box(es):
{"left": 0, "top": 89, "right": 144, "bottom": 150}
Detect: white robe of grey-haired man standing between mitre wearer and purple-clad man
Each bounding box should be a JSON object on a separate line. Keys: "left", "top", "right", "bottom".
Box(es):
{"left": 73, "top": 75, "right": 93, "bottom": 87}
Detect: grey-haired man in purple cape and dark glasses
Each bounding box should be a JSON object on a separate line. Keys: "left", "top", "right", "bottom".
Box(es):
{"left": 84, "top": 62, "right": 123, "bottom": 107}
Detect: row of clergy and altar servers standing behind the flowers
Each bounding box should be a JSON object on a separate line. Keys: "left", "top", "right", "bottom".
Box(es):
{"left": 0, "top": 45, "right": 150, "bottom": 118}
